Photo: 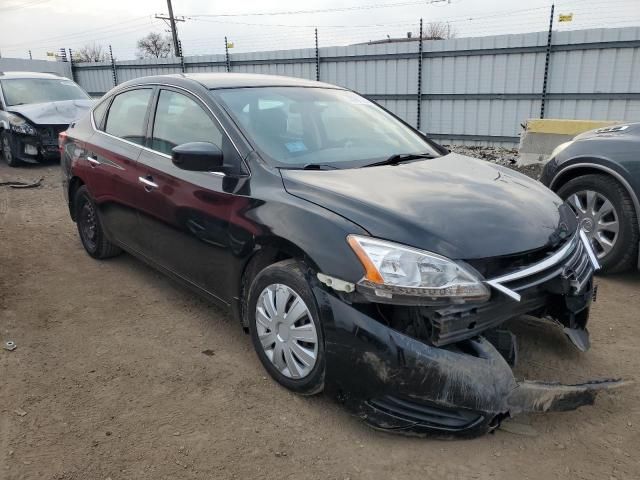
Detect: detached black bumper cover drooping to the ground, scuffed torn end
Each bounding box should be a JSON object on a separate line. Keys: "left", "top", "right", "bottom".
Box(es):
{"left": 315, "top": 287, "right": 623, "bottom": 436}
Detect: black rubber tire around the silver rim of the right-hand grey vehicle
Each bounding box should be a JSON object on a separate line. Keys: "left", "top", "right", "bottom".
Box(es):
{"left": 558, "top": 174, "right": 640, "bottom": 273}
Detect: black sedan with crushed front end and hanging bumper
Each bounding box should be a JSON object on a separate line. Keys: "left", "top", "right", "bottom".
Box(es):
{"left": 60, "top": 74, "right": 618, "bottom": 435}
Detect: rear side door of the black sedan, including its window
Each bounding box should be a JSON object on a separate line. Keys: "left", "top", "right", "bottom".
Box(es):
{"left": 84, "top": 87, "right": 154, "bottom": 250}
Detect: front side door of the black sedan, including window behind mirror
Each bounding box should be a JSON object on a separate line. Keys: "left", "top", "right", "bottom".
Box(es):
{"left": 139, "top": 87, "right": 246, "bottom": 303}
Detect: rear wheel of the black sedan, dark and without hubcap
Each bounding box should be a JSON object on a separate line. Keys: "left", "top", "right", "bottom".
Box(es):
{"left": 73, "top": 185, "right": 122, "bottom": 260}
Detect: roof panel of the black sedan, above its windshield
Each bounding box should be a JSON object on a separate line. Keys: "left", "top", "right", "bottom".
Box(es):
{"left": 119, "top": 72, "right": 342, "bottom": 90}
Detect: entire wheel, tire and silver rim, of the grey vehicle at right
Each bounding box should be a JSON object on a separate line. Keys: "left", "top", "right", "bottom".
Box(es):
{"left": 558, "top": 175, "right": 640, "bottom": 273}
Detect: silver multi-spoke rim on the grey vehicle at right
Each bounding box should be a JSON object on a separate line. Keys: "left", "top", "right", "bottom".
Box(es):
{"left": 567, "top": 190, "right": 620, "bottom": 258}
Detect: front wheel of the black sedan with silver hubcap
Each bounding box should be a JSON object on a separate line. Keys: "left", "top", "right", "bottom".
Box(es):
{"left": 246, "top": 260, "right": 325, "bottom": 395}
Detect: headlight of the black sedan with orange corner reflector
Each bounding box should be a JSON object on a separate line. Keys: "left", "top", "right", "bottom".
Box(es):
{"left": 347, "top": 235, "right": 490, "bottom": 303}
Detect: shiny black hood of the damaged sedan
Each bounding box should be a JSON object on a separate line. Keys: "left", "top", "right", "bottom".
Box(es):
{"left": 281, "top": 153, "right": 577, "bottom": 260}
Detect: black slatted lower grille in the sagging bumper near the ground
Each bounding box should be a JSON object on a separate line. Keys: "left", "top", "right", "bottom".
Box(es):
{"left": 367, "top": 395, "right": 484, "bottom": 432}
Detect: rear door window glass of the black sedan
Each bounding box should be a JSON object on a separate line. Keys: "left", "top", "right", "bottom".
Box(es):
{"left": 104, "top": 88, "right": 152, "bottom": 145}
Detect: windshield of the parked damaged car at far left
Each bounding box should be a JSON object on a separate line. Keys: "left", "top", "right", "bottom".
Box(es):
{"left": 0, "top": 78, "right": 89, "bottom": 107}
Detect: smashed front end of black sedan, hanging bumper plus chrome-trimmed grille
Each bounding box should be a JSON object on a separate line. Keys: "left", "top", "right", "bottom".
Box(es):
{"left": 314, "top": 231, "right": 623, "bottom": 436}
